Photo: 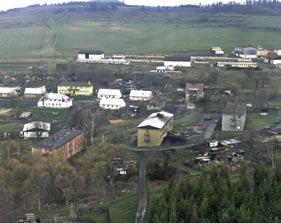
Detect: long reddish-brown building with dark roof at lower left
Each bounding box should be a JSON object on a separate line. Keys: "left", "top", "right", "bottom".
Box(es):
{"left": 32, "top": 129, "right": 84, "bottom": 159}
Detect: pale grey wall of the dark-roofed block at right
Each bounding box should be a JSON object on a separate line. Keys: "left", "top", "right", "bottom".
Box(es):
{"left": 222, "top": 114, "right": 246, "bottom": 131}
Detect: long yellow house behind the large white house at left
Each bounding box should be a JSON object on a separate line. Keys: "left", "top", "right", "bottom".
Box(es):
{"left": 57, "top": 81, "right": 93, "bottom": 96}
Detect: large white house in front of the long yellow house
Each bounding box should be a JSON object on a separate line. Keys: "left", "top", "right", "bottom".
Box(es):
{"left": 37, "top": 93, "right": 72, "bottom": 108}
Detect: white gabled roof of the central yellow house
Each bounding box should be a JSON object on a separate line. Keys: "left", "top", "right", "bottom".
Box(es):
{"left": 137, "top": 111, "right": 174, "bottom": 129}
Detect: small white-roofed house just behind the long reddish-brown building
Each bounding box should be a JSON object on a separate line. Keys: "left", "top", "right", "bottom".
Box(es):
{"left": 20, "top": 121, "right": 51, "bottom": 139}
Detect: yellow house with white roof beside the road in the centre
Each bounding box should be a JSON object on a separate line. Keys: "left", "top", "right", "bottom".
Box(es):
{"left": 137, "top": 111, "right": 174, "bottom": 147}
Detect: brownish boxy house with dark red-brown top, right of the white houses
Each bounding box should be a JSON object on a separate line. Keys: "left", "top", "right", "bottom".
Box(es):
{"left": 185, "top": 83, "right": 204, "bottom": 102}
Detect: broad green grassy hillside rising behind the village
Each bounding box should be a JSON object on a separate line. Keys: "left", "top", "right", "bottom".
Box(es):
{"left": 0, "top": 2, "right": 281, "bottom": 59}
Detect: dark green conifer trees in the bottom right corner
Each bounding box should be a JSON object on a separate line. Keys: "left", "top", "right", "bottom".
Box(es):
{"left": 148, "top": 166, "right": 281, "bottom": 223}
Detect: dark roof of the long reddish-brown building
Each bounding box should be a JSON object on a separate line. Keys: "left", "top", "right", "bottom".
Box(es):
{"left": 33, "top": 129, "right": 83, "bottom": 150}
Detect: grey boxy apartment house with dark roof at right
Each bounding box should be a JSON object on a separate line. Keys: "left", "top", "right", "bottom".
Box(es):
{"left": 222, "top": 102, "right": 247, "bottom": 131}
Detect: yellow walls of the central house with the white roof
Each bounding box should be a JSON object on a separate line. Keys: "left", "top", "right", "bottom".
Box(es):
{"left": 138, "top": 118, "right": 173, "bottom": 147}
